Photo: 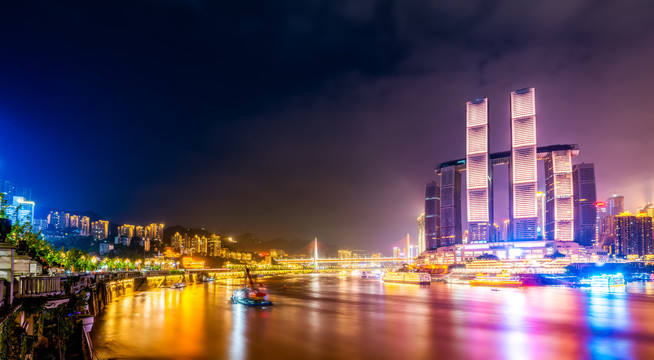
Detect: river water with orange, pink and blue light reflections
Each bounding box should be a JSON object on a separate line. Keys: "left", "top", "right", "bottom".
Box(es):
{"left": 92, "top": 275, "right": 654, "bottom": 360}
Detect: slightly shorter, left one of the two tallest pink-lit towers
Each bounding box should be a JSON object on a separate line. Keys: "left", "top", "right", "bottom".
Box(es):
{"left": 466, "top": 98, "right": 493, "bottom": 243}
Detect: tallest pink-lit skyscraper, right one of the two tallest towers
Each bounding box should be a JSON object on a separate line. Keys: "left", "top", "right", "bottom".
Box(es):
{"left": 509, "top": 88, "right": 538, "bottom": 240}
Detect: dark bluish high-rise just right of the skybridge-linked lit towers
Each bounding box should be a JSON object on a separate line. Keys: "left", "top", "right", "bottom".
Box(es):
{"left": 572, "top": 163, "right": 597, "bottom": 246}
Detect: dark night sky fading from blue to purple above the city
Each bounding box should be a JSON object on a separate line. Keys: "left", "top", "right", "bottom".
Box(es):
{"left": 0, "top": 0, "right": 654, "bottom": 252}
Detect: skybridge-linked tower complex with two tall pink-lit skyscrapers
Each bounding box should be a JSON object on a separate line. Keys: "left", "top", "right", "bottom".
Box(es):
{"left": 434, "top": 88, "right": 578, "bottom": 248}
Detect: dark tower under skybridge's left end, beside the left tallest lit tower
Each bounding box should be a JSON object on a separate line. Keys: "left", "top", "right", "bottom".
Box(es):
{"left": 437, "top": 165, "right": 463, "bottom": 247}
